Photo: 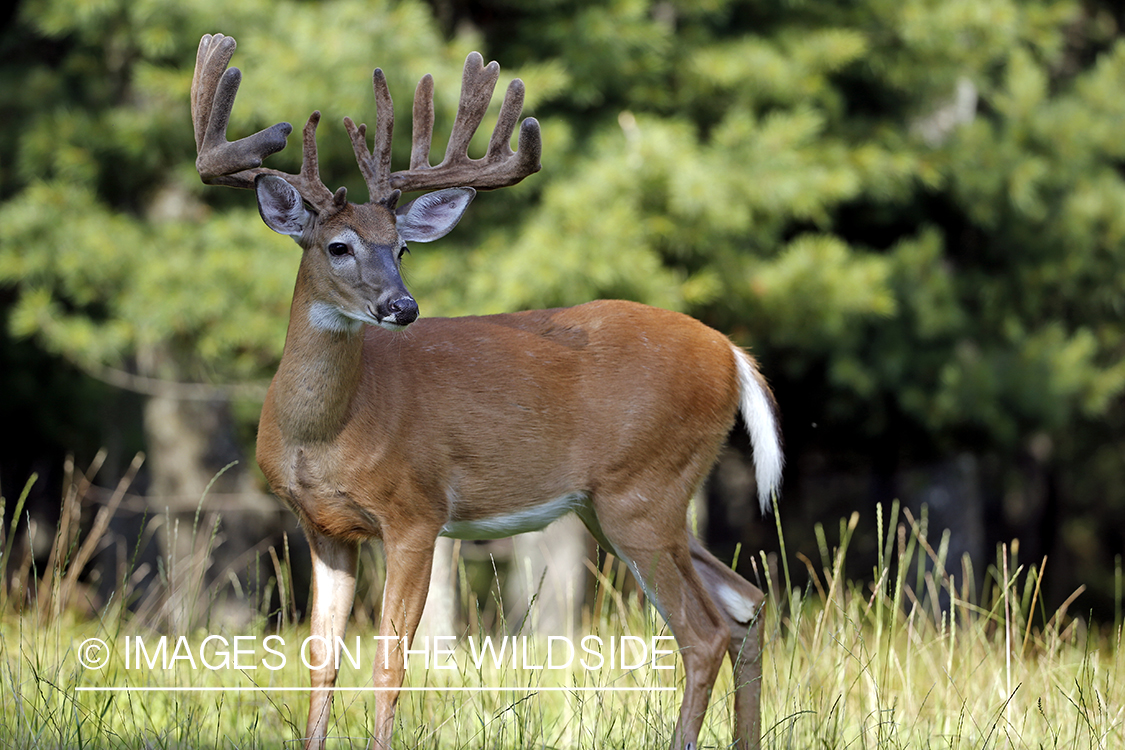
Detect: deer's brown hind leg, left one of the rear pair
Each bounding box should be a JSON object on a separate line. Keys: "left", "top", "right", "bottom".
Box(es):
{"left": 588, "top": 497, "right": 730, "bottom": 750}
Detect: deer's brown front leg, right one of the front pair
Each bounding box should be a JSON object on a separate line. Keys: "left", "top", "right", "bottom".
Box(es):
{"left": 371, "top": 528, "right": 438, "bottom": 750}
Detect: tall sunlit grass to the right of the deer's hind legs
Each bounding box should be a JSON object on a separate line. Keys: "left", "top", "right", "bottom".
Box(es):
{"left": 764, "top": 506, "right": 1125, "bottom": 748}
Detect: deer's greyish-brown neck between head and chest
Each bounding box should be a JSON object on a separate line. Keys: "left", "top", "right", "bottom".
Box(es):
{"left": 270, "top": 264, "right": 363, "bottom": 443}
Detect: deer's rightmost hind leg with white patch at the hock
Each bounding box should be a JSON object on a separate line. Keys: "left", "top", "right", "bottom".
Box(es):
{"left": 691, "top": 537, "right": 765, "bottom": 750}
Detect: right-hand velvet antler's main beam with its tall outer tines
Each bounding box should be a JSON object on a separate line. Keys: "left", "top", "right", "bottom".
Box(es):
{"left": 389, "top": 52, "right": 542, "bottom": 192}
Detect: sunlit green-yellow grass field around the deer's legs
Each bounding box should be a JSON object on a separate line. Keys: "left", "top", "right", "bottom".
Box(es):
{"left": 0, "top": 465, "right": 1125, "bottom": 750}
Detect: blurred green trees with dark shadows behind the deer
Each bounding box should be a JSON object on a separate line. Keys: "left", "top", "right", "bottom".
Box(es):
{"left": 0, "top": 0, "right": 1125, "bottom": 612}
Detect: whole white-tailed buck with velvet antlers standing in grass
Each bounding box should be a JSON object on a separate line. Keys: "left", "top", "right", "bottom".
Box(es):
{"left": 191, "top": 34, "right": 782, "bottom": 749}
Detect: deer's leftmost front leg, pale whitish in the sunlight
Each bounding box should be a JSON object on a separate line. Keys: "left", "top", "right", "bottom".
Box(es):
{"left": 305, "top": 531, "right": 359, "bottom": 750}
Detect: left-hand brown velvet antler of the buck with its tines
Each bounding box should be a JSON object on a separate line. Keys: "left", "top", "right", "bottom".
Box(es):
{"left": 191, "top": 34, "right": 344, "bottom": 210}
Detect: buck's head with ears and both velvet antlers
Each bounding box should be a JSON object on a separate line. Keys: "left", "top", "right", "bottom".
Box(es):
{"left": 191, "top": 34, "right": 541, "bottom": 333}
